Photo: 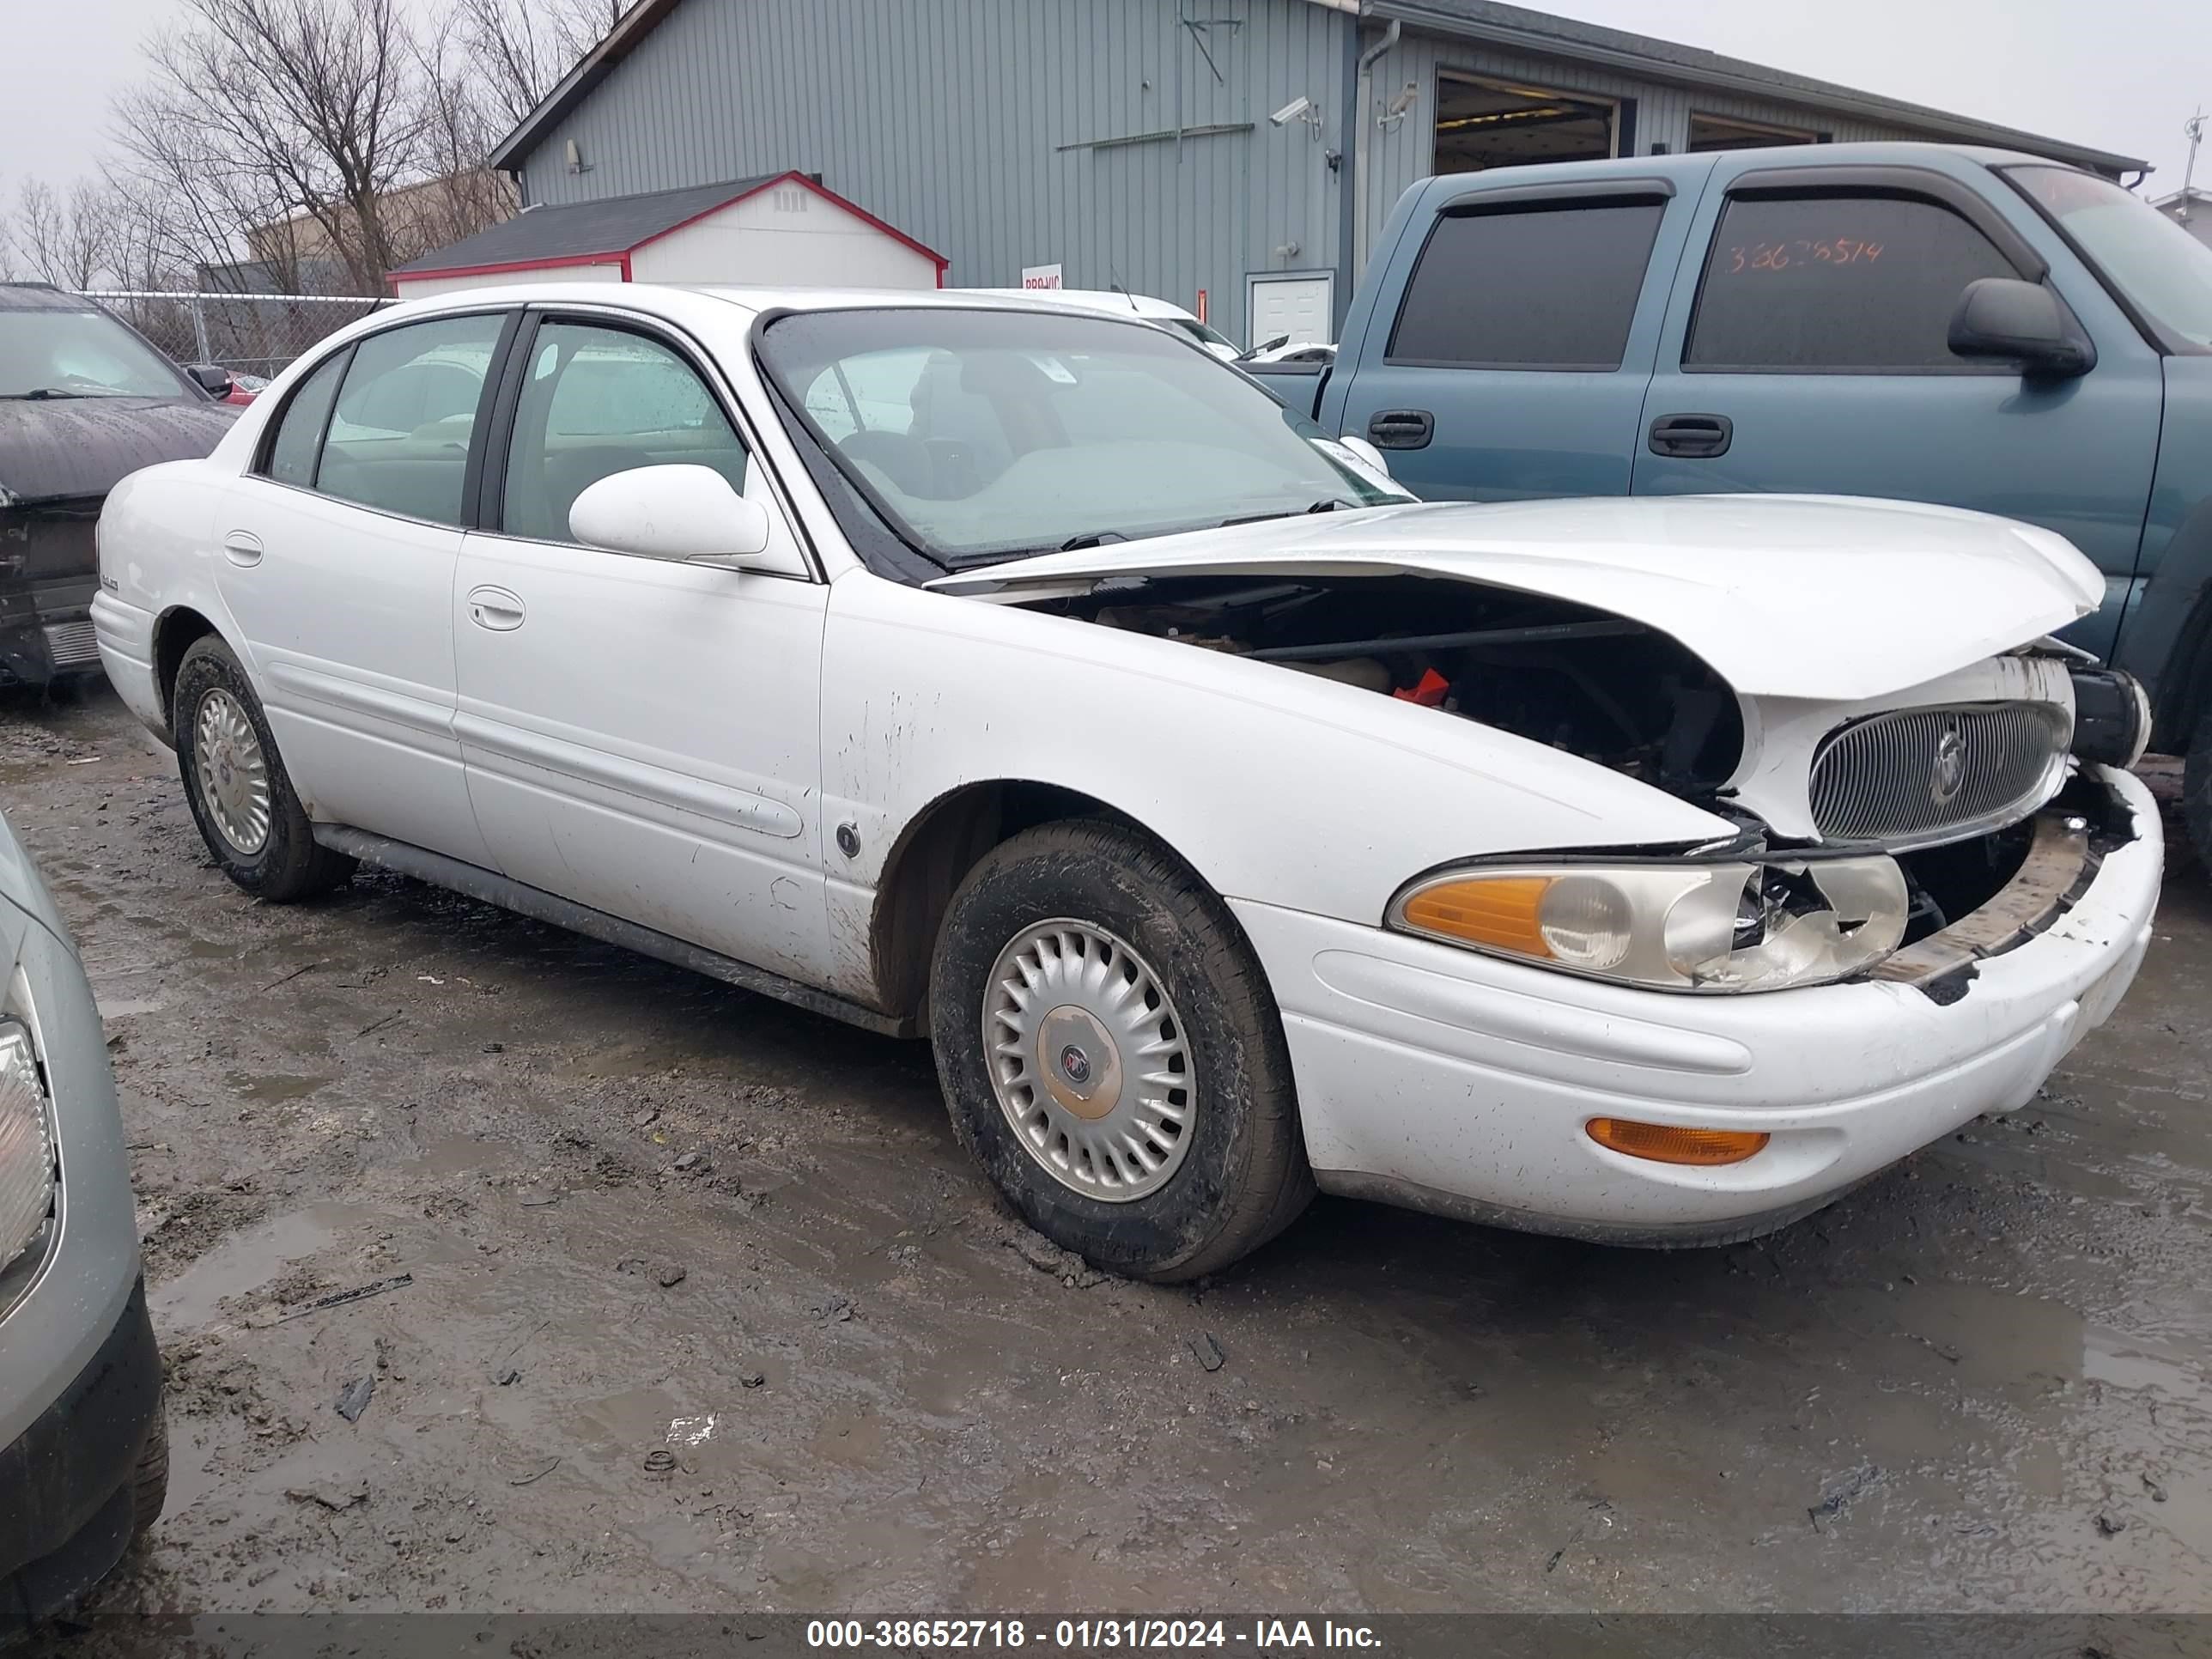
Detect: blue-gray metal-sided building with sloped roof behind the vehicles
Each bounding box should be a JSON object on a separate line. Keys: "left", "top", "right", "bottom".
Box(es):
{"left": 493, "top": 0, "right": 2143, "bottom": 338}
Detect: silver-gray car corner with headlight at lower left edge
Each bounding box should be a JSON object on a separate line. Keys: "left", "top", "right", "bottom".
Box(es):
{"left": 0, "top": 818, "right": 168, "bottom": 1639}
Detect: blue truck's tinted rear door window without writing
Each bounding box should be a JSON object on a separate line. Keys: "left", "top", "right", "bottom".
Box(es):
{"left": 1387, "top": 201, "right": 1666, "bottom": 372}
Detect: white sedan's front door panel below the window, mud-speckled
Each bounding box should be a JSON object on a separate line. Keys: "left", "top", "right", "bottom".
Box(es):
{"left": 453, "top": 535, "right": 827, "bottom": 980}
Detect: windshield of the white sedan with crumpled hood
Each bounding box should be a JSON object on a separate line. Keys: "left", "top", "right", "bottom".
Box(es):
{"left": 761, "top": 307, "right": 1407, "bottom": 566}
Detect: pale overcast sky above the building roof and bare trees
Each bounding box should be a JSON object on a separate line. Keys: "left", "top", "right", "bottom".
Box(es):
{"left": 0, "top": 0, "right": 2212, "bottom": 197}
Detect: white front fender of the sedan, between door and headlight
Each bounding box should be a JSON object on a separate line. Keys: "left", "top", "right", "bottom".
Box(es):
{"left": 823, "top": 571, "right": 1735, "bottom": 994}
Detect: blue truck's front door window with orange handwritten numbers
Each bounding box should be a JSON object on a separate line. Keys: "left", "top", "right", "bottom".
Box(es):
{"left": 1681, "top": 195, "right": 2020, "bottom": 374}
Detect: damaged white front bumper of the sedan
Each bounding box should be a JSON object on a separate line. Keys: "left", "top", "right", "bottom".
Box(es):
{"left": 1232, "top": 768, "right": 2163, "bottom": 1245}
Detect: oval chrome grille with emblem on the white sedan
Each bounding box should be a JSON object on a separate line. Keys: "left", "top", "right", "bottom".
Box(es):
{"left": 1812, "top": 703, "right": 2073, "bottom": 842}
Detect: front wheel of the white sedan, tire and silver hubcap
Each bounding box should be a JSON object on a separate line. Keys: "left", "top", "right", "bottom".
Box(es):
{"left": 929, "top": 821, "right": 1314, "bottom": 1281}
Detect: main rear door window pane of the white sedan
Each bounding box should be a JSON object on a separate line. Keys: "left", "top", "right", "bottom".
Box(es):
{"left": 316, "top": 314, "right": 507, "bottom": 525}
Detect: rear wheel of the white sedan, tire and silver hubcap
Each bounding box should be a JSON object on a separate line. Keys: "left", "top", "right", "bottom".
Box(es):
{"left": 170, "top": 635, "right": 354, "bottom": 902}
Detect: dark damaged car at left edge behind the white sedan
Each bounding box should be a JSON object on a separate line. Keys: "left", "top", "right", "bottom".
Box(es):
{"left": 0, "top": 283, "right": 237, "bottom": 686}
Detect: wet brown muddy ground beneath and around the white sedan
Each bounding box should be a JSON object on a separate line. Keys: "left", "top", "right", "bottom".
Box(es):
{"left": 0, "top": 690, "right": 2212, "bottom": 1614}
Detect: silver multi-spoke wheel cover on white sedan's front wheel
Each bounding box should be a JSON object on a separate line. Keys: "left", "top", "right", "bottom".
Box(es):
{"left": 982, "top": 918, "right": 1197, "bottom": 1203}
